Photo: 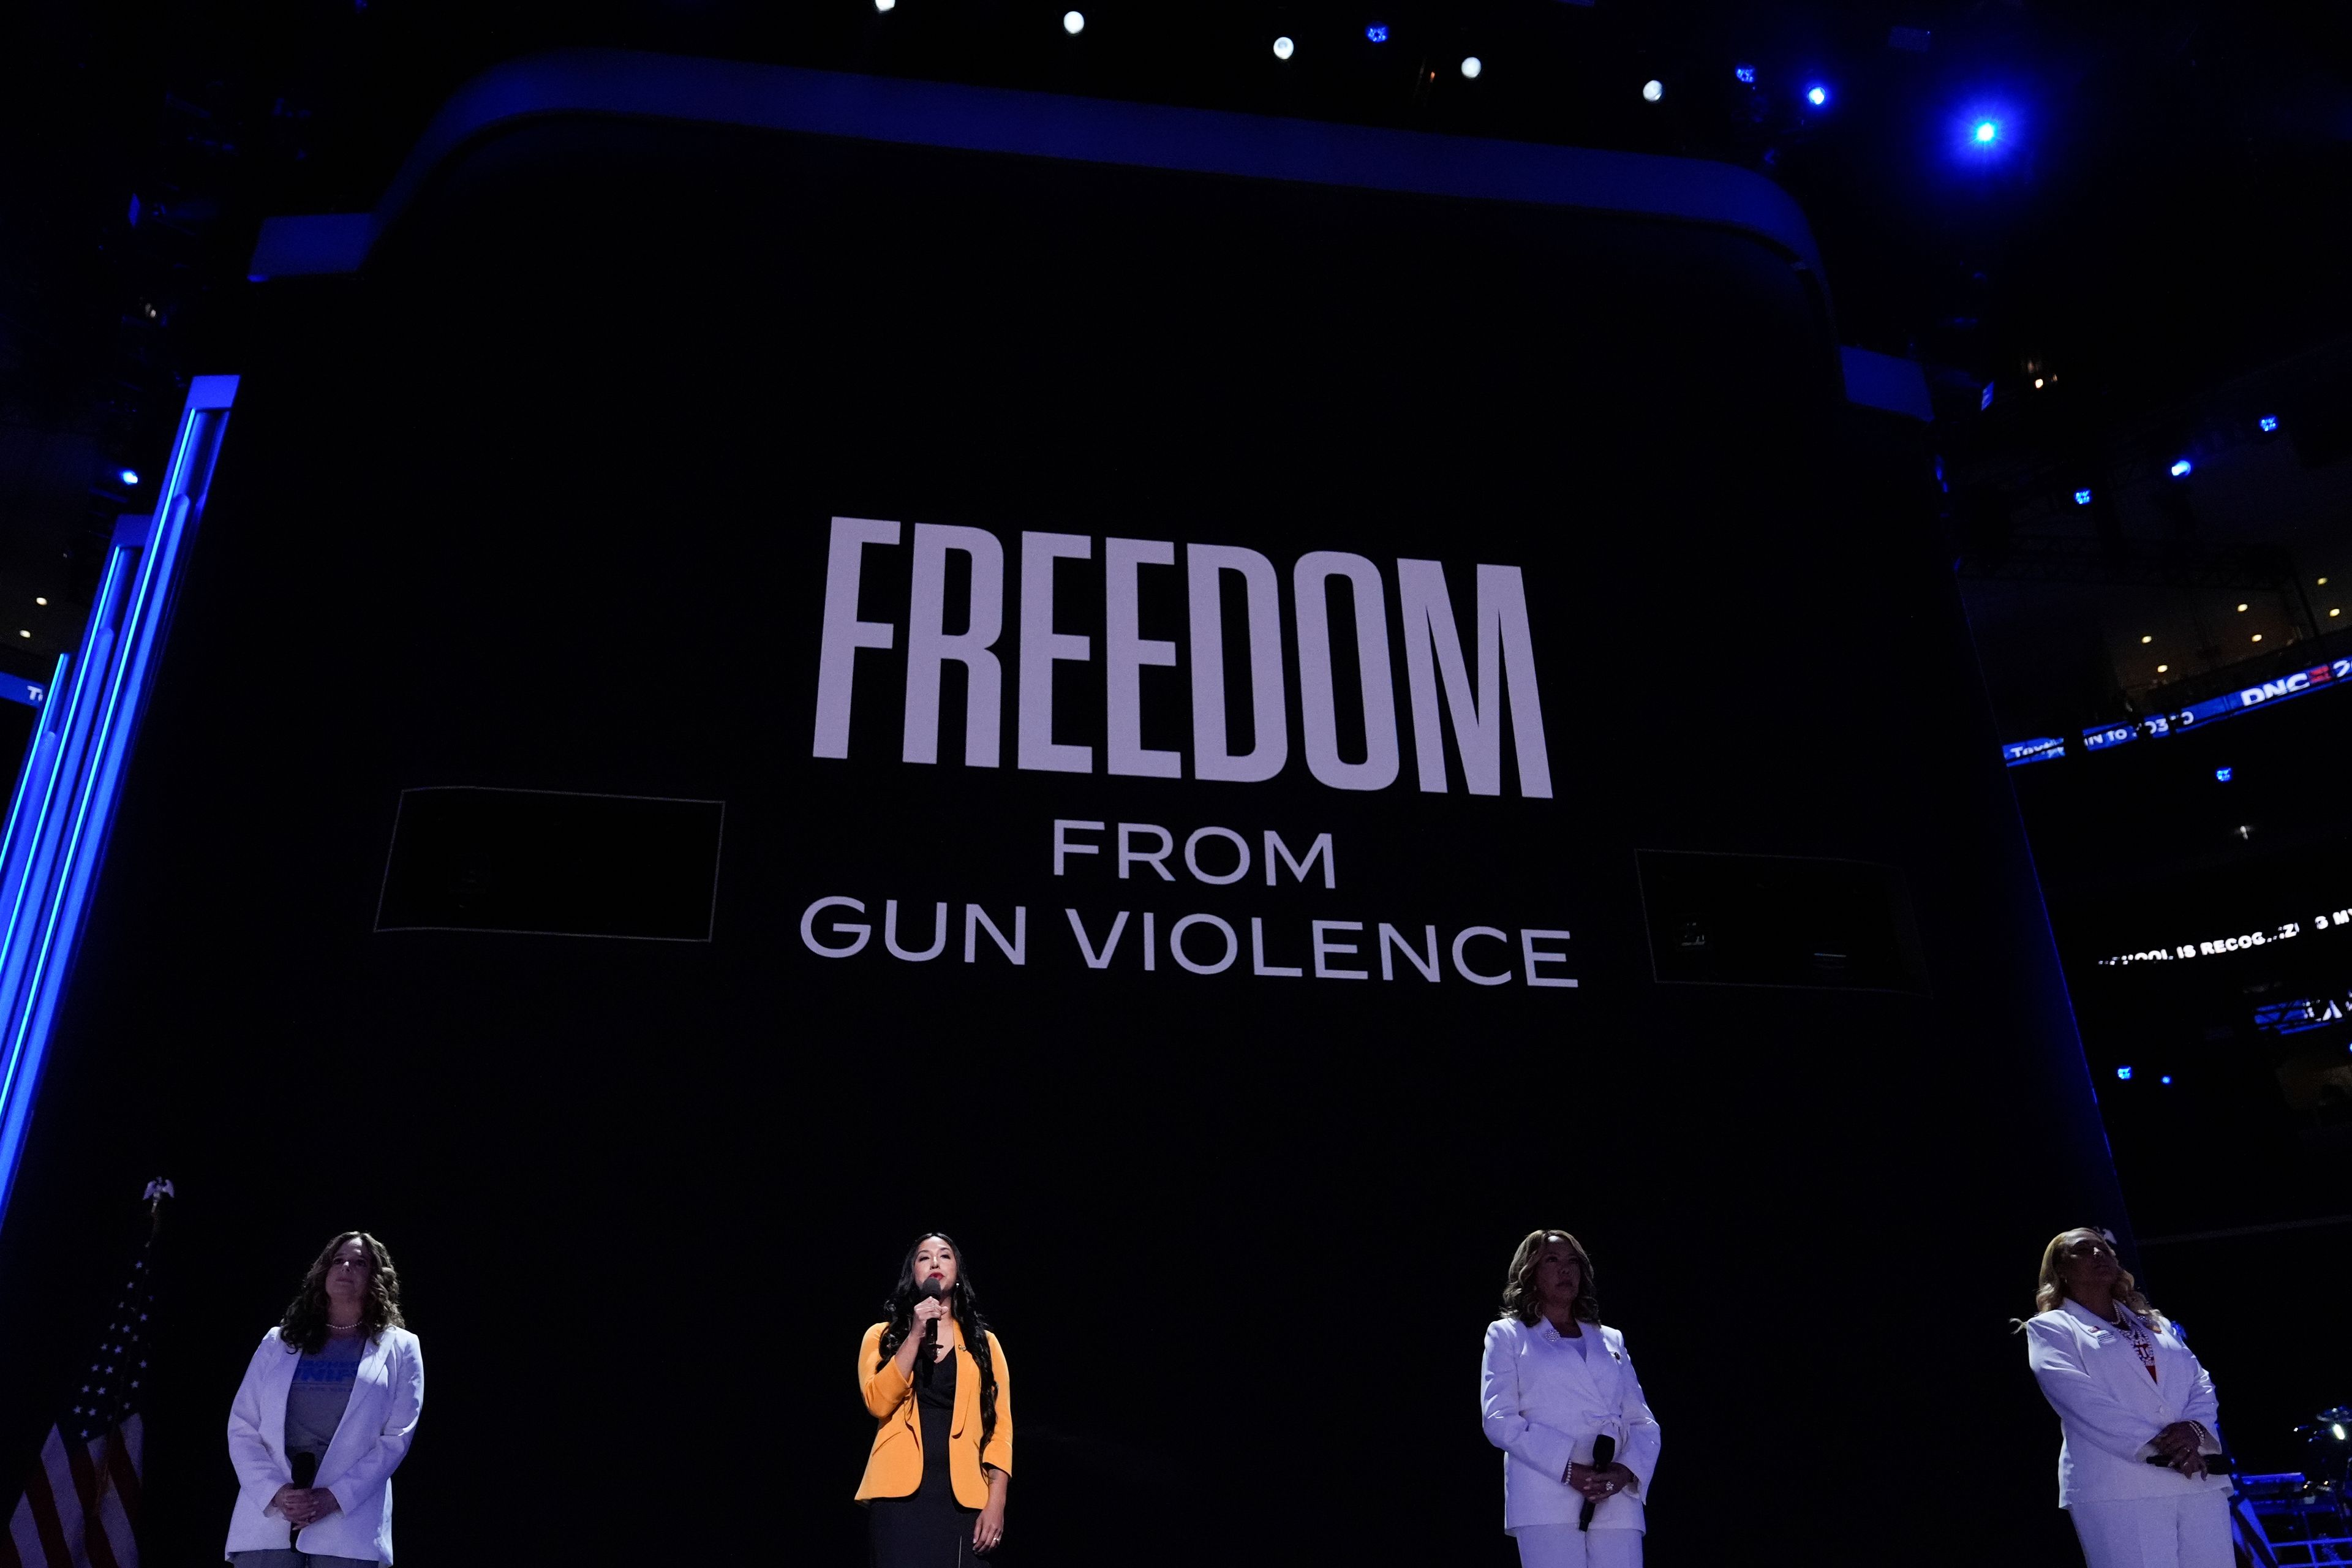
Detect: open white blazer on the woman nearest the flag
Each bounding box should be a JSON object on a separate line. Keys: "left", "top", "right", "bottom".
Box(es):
{"left": 221, "top": 1329, "right": 426, "bottom": 1563}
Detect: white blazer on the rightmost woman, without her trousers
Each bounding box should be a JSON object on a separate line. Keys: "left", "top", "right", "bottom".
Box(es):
{"left": 2025, "top": 1300, "right": 2230, "bottom": 1509}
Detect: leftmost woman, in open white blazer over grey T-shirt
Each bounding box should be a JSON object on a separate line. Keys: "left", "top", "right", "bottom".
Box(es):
{"left": 224, "top": 1229, "right": 426, "bottom": 1568}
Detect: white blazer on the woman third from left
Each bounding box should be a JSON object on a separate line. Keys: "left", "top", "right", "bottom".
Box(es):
{"left": 1477, "top": 1316, "right": 1658, "bottom": 1532}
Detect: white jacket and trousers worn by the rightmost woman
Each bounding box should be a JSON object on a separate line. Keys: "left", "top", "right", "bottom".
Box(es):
{"left": 2025, "top": 1300, "right": 2234, "bottom": 1568}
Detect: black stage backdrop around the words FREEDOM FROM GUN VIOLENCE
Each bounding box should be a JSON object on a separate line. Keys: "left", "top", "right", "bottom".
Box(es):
{"left": 0, "top": 101, "right": 2145, "bottom": 1566}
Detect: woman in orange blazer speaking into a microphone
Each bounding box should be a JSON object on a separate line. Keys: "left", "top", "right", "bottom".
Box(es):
{"left": 859, "top": 1232, "right": 1014, "bottom": 1568}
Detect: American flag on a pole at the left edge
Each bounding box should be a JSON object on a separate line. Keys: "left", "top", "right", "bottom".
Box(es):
{"left": 0, "top": 1180, "right": 172, "bottom": 1568}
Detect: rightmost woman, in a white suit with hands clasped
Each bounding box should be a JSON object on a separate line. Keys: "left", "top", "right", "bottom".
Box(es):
{"left": 2025, "top": 1229, "right": 2237, "bottom": 1568}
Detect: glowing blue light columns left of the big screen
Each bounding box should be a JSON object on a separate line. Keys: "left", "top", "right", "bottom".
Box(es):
{"left": 0, "top": 376, "right": 238, "bottom": 1220}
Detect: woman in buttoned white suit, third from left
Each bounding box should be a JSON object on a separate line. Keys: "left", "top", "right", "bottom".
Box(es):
{"left": 1479, "top": 1229, "right": 1658, "bottom": 1568}
